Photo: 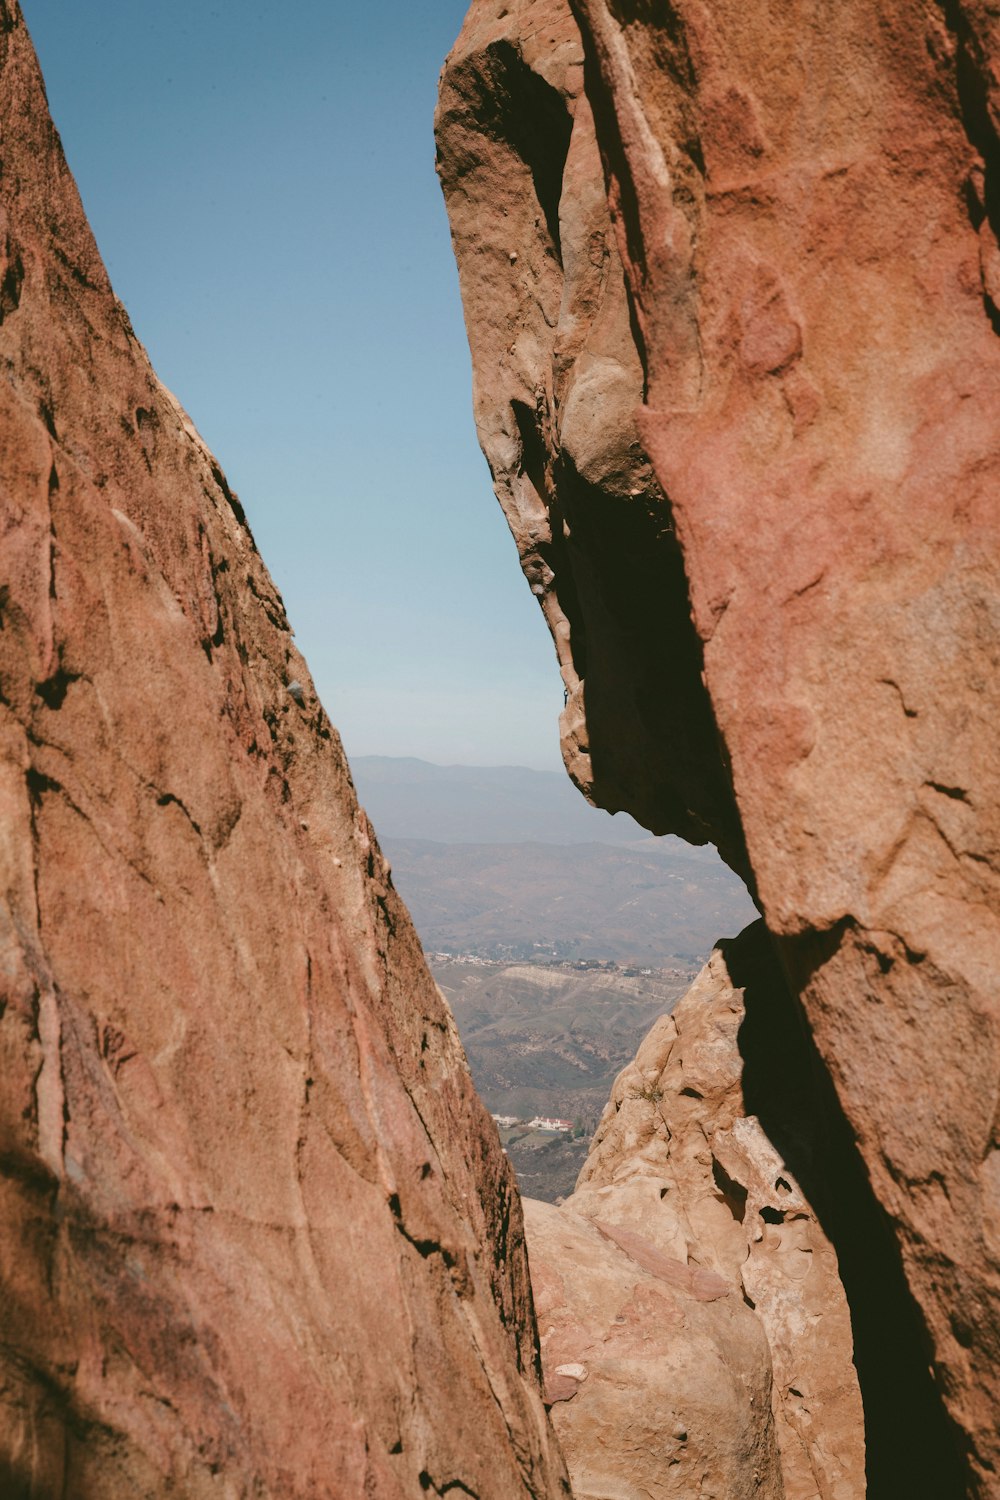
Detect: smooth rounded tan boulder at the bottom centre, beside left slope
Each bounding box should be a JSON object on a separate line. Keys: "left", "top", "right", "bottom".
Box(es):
{"left": 523, "top": 1199, "right": 783, "bottom": 1500}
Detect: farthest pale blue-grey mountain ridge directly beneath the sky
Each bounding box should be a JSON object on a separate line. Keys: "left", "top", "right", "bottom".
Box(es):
{"left": 351, "top": 755, "right": 649, "bottom": 845}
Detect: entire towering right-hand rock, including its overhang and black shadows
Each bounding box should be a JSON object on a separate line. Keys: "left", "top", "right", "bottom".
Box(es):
{"left": 438, "top": 0, "right": 1000, "bottom": 1497}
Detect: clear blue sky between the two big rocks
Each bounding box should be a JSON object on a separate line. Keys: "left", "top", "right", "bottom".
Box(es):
{"left": 22, "top": 0, "right": 562, "bottom": 767}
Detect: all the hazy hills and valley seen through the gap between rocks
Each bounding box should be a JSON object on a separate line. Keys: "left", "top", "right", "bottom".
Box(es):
{"left": 352, "top": 756, "right": 756, "bottom": 1200}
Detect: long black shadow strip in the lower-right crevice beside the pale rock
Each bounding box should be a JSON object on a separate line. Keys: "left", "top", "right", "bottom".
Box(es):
{"left": 720, "top": 923, "right": 967, "bottom": 1500}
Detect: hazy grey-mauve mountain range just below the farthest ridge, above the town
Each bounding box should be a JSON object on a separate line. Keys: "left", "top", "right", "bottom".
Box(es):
{"left": 381, "top": 836, "right": 757, "bottom": 968}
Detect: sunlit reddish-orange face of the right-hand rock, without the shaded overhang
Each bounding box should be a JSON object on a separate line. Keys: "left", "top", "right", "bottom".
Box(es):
{"left": 576, "top": 0, "right": 1000, "bottom": 1496}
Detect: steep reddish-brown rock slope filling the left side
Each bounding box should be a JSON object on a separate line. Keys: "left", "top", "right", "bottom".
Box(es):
{"left": 0, "top": 0, "right": 567, "bottom": 1500}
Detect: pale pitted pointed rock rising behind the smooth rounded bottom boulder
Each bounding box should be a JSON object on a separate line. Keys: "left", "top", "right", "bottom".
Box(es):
{"left": 565, "top": 924, "right": 865, "bottom": 1500}
